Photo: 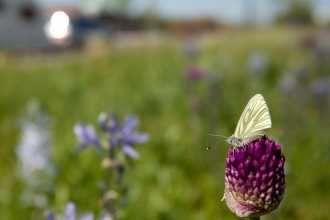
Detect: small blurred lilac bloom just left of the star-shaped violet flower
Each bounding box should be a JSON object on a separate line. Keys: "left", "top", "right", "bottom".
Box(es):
{"left": 73, "top": 122, "right": 99, "bottom": 148}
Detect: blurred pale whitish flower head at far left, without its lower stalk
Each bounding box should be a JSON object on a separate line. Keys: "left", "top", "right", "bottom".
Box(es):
{"left": 16, "top": 100, "right": 54, "bottom": 186}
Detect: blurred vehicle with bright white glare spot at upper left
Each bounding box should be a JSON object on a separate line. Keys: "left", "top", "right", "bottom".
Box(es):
{"left": 0, "top": 0, "right": 112, "bottom": 49}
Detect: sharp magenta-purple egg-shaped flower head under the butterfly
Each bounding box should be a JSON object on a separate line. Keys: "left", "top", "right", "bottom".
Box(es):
{"left": 225, "top": 136, "right": 285, "bottom": 217}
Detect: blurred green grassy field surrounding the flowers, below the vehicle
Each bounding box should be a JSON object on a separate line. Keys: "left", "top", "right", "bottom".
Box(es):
{"left": 0, "top": 28, "right": 330, "bottom": 220}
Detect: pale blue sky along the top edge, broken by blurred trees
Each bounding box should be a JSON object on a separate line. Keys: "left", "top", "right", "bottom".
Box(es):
{"left": 35, "top": 0, "right": 330, "bottom": 25}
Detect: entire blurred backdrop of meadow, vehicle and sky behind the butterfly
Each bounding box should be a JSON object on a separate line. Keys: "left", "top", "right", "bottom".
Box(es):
{"left": 0, "top": 0, "right": 330, "bottom": 220}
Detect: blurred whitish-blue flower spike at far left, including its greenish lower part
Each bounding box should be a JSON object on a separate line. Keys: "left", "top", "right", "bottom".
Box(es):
{"left": 15, "top": 100, "right": 56, "bottom": 208}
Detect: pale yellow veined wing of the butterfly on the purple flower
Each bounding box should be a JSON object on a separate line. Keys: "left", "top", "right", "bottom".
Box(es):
{"left": 234, "top": 94, "right": 272, "bottom": 144}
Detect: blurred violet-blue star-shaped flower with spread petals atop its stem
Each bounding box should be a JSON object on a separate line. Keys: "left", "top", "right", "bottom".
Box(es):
{"left": 98, "top": 112, "right": 149, "bottom": 158}
